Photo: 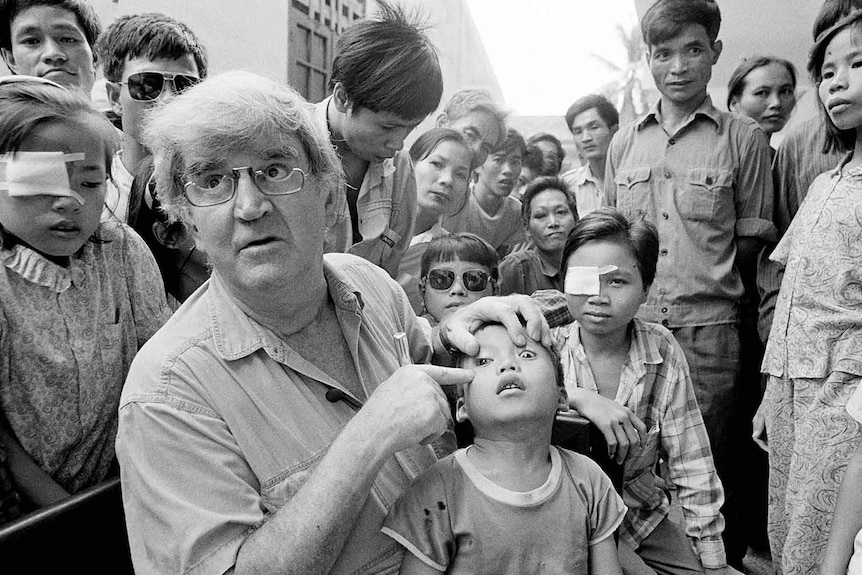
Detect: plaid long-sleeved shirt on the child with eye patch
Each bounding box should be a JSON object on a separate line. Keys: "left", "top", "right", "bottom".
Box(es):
{"left": 553, "top": 319, "right": 726, "bottom": 568}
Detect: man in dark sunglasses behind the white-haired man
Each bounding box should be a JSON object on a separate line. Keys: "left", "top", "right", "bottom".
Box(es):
{"left": 97, "top": 13, "right": 207, "bottom": 225}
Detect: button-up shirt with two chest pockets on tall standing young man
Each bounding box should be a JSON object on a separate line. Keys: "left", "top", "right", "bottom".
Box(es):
{"left": 605, "top": 97, "right": 775, "bottom": 327}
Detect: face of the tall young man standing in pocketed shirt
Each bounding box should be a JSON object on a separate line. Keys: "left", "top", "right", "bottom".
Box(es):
{"left": 648, "top": 24, "right": 721, "bottom": 107}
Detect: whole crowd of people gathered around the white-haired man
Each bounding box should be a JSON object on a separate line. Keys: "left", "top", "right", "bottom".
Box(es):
{"left": 0, "top": 0, "right": 862, "bottom": 575}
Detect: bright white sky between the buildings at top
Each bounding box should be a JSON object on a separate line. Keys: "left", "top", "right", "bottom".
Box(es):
{"left": 467, "top": 0, "right": 637, "bottom": 116}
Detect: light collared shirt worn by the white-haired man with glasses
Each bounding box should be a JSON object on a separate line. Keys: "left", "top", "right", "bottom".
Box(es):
{"left": 117, "top": 254, "right": 435, "bottom": 575}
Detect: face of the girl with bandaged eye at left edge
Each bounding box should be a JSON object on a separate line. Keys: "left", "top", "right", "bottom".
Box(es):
{"left": 0, "top": 118, "right": 108, "bottom": 257}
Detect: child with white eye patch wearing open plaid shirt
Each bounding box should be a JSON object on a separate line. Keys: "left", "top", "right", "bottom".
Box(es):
{"left": 553, "top": 208, "right": 740, "bottom": 573}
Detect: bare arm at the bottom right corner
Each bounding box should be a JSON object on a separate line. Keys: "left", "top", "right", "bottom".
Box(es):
{"left": 820, "top": 445, "right": 862, "bottom": 575}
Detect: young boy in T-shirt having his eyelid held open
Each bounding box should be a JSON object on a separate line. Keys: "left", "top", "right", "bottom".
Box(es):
{"left": 383, "top": 323, "right": 625, "bottom": 575}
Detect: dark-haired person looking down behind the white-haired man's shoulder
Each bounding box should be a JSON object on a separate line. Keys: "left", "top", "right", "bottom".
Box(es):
{"left": 315, "top": 2, "right": 443, "bottom": 278}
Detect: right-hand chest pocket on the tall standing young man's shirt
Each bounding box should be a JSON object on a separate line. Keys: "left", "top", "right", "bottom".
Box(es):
{"left": 676, "top": 169, "right": 733, "bottom": 220}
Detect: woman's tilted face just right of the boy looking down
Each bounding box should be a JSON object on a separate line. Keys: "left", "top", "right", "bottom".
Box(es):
{"left": 413, "top": 140, "right": 473, "bottom": 215}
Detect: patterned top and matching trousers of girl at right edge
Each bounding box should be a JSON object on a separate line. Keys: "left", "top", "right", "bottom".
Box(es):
{"left": 762, "top": 160, "right": 862, "bottom": 574}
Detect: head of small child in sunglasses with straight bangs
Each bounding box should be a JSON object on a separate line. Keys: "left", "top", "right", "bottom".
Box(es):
{"left": 419, "top": 232, "right": 500, "bottom": 326}
